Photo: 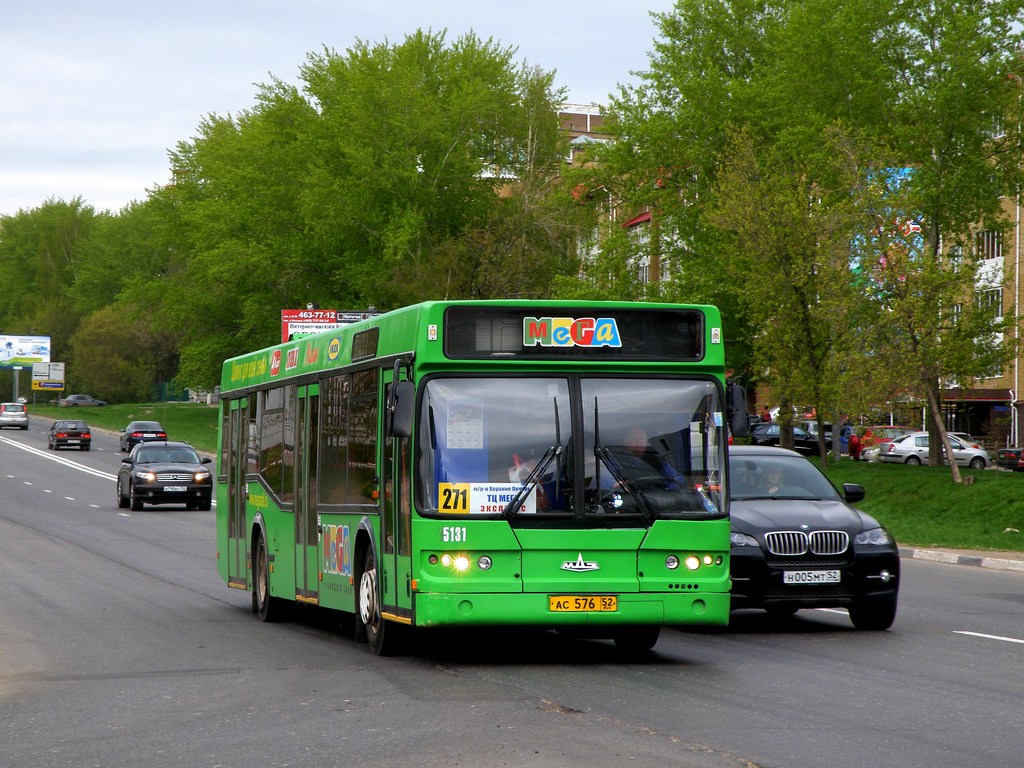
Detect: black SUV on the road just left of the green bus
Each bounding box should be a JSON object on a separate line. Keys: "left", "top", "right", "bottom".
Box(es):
{"left": 117, "top": 441, "right": 213, "bottom": 512}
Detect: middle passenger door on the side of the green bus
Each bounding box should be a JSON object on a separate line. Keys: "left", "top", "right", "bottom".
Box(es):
{"left": 295, "top": 384, "right": 319, "bottom": 603}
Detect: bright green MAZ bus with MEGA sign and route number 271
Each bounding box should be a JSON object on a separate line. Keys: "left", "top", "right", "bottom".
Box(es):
{"left": 216, "top": 300, "right": 748, "bottom": 653}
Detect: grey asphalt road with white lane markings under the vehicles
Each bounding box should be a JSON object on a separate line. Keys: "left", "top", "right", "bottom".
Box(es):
{"left": 0, "top": 427, "right": 1024, "bottom": 768}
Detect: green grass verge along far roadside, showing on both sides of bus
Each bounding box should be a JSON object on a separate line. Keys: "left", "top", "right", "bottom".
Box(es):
{"left": 29, "top": 402, "right": 1024, "bottom": 552}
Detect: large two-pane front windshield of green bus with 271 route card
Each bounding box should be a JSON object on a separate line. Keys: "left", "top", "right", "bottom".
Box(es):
{"left": 417, "top": 376, "right": 725, "bottom": 522}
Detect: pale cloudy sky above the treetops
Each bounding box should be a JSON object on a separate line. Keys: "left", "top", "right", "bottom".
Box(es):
{"left": 0, "top": 0, "right": 675, "bottom": 215}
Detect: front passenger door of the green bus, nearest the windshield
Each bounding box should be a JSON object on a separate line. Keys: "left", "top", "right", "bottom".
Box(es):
{"left": 381, "top": 371, "right": 413, "bottom": 617}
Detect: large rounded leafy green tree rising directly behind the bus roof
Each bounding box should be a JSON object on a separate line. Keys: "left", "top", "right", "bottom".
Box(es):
{"left": 156, "top": 32, "right": 568, "bottom": 386}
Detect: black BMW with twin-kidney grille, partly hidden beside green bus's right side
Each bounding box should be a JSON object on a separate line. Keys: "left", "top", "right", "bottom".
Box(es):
{"left": 729, "top": 445, "right": 899, "bottom": 630}
